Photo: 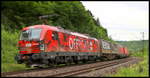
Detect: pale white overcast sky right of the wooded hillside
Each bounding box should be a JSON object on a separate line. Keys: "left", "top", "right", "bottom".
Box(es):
{"left": 81, "top": 1, "right": 149, "bottom": 41}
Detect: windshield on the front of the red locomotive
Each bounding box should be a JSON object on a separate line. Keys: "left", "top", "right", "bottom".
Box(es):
{"left": 20, "top": 29, "right": 41, "bottom": 40}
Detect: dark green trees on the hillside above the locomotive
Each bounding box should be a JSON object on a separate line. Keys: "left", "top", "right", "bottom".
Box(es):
{"left": 1, "top": 1, "right": 110, "bottom": 40}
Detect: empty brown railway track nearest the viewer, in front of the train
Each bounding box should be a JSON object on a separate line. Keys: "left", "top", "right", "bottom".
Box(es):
{"left": 48, "top": 58, "right": 141, "bottom": 77}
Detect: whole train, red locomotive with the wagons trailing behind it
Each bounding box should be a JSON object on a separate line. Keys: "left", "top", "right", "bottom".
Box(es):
{"left": 15, "top": 25, "right": 128, "bottom": 66}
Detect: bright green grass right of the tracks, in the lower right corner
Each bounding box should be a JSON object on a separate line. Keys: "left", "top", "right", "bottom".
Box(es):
{"left": 109, "top": 46, "right": 149, "bottom": 77}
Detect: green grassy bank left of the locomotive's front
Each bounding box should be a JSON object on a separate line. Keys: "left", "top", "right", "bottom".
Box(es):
{"left": 1, "top": 30, "right": 29, "bottom": 72}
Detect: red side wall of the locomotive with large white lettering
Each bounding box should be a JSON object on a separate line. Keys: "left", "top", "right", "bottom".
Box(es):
{"left": 44, "top": 30, "right": 99, "bottom": 52}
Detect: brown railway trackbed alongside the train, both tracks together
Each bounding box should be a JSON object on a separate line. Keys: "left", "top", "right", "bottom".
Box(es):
{"left": 2, "top": 57, "right": 142, "bottom": 77}
